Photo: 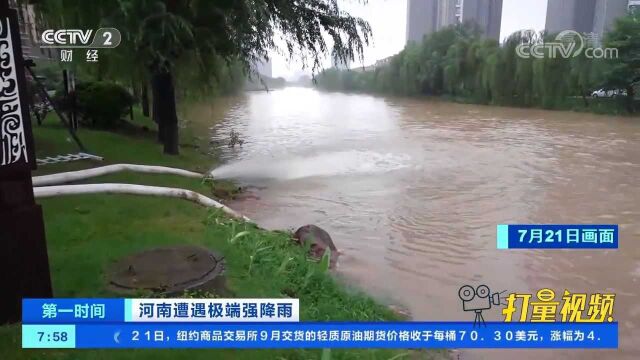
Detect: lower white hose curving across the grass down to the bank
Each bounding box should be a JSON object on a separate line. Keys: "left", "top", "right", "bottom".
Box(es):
{"left": 33, "top": 184, "right": 251, "bottom": 221}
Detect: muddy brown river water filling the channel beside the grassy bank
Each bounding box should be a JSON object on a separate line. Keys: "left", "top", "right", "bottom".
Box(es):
{"left": 194, "top": 88, "right": 640, "bottom": 359}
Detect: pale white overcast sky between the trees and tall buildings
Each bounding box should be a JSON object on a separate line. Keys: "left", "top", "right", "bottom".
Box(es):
{"left": 272, "top": 0, "right": 547, "bottom": 79}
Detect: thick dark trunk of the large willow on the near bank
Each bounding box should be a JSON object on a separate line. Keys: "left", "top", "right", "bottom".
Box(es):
{"left": 153, "top": 70, "right": 179, "bottom": 155}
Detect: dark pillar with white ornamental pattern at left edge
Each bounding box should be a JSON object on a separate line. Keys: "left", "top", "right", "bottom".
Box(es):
{"left": 0, "top": 0, "right": 53, "bottom": 324}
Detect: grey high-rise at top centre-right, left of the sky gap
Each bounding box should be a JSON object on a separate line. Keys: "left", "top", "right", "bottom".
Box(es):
{"left": 407, "top": 0, "right": 502, "bottom": 42}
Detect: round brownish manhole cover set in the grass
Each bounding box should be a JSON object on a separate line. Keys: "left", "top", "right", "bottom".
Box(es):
{"left": 109, "top": 246, "right": 224, "bottom": 294}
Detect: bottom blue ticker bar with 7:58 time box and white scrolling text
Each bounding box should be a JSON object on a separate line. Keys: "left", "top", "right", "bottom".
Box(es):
{"left": 22, "top": 322, "right": 618, "bottom": 349}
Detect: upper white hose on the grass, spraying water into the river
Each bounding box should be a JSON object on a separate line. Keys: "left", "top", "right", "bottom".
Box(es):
{"left": 32, "top": 164, "right": 204, "bottom": 186}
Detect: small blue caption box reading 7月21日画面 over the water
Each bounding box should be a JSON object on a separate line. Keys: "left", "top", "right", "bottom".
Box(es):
{"left": 496, "top": 224, "right": 619, "bottom": 249}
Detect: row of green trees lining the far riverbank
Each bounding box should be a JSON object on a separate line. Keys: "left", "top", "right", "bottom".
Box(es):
{"left": 317, "top": 14, "right": 640, "bottom": 110}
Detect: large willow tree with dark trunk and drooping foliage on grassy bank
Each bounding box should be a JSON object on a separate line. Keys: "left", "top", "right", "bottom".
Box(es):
{"left": 42, "top": 0, "right": 371, "bottom": 154}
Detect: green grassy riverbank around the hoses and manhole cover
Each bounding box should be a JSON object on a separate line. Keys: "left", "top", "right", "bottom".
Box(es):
{"left": 0, "top": 112, "right": 445, "bottom": 359}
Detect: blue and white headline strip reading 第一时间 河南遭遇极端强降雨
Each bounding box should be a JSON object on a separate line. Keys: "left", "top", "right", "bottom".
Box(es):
{"left": 22, "top": 298, "right": 300, "bottom": 324}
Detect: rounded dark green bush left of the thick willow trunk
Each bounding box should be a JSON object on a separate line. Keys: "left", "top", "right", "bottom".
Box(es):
{"left": 75, "top": 81, "right": 133, "bottom": 128}
